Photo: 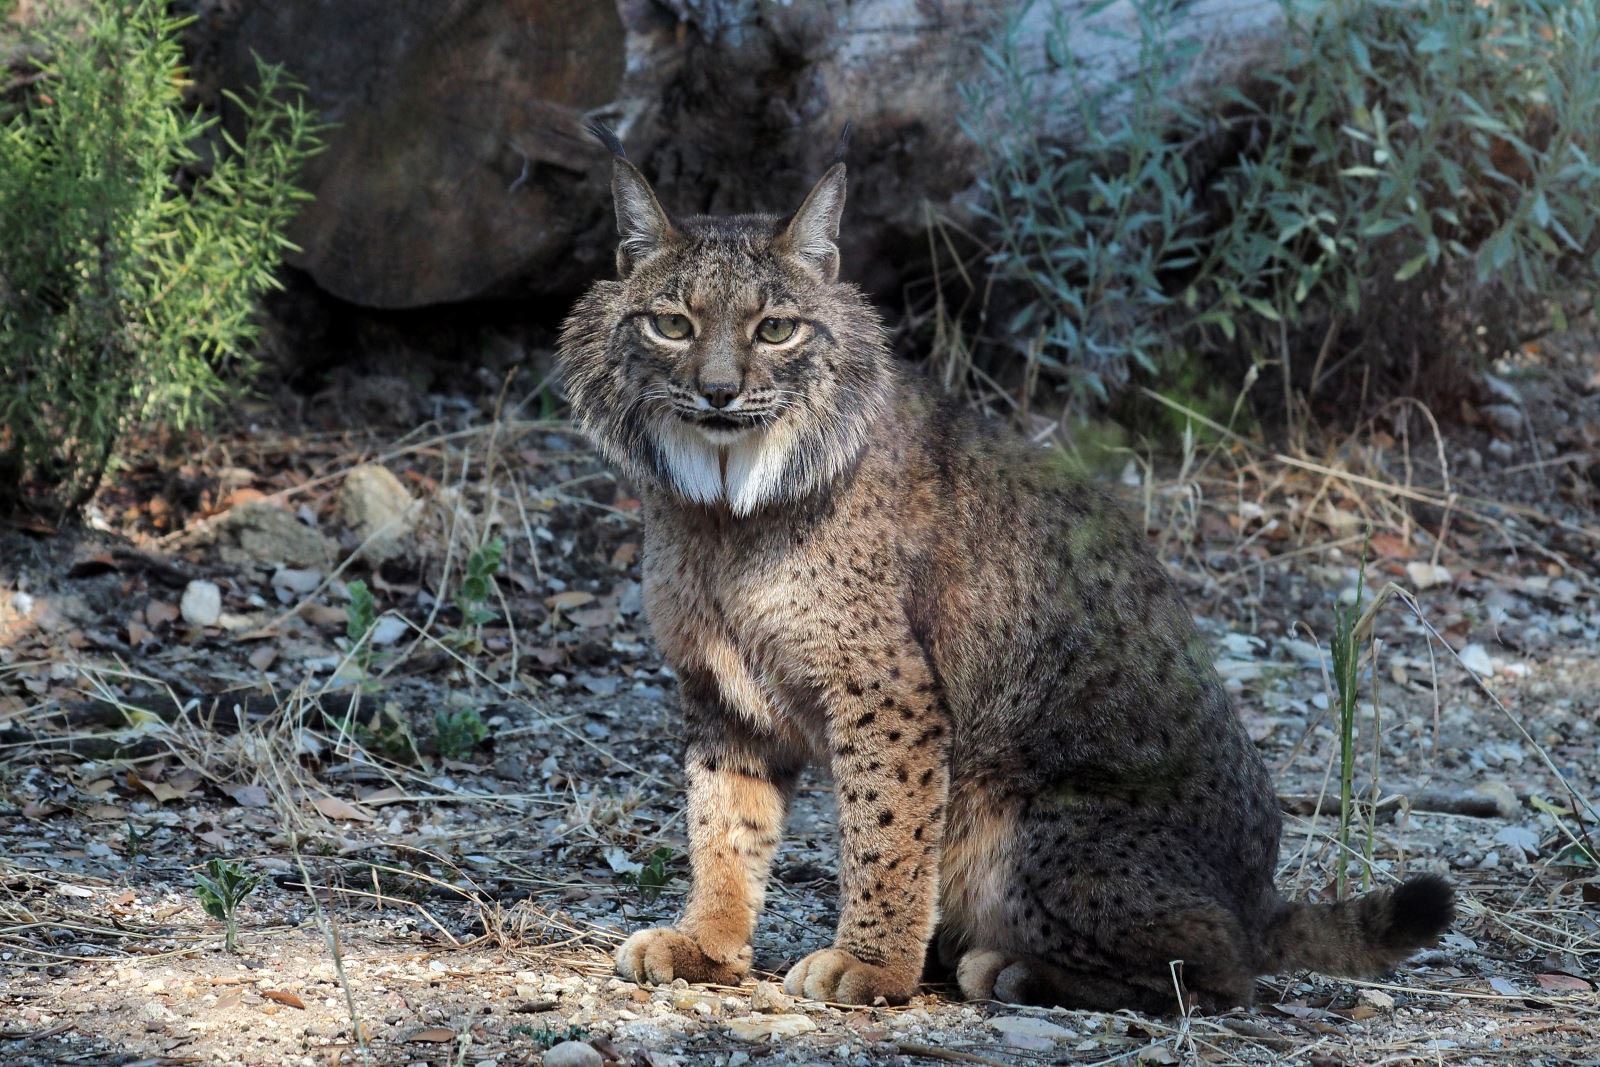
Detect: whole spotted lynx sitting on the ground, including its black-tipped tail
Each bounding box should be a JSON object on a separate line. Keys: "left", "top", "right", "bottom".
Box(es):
{"left": 562, "top": 130, "right": 1453, "bottom": 1013}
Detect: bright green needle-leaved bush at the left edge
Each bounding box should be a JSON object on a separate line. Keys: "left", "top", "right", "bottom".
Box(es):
{"left": 0, "top": 0, "right": 318, "bottom": 514}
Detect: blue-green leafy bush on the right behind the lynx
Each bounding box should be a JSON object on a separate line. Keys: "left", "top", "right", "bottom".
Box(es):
{"left": 968, "top": 0, "right": 1600, "bottom": 409}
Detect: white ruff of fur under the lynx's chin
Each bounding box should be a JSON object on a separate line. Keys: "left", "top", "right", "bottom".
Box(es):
{"left": 656, "top": 424, "right": 813, "bottom": 517}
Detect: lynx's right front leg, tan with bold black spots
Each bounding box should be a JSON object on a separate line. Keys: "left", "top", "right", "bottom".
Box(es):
{"left": 784, "top": 640, "right": 949, "bottom": 1005}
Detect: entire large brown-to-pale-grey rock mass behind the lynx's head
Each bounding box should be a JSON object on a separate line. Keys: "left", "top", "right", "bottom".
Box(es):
{"left": 200, "top": 0, "right": 1299, "bottom": 307}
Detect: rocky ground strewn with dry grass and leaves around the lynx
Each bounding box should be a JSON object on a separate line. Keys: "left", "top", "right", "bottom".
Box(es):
{"left": 0, "top": 339, "right": 1600, "bottom": 1065}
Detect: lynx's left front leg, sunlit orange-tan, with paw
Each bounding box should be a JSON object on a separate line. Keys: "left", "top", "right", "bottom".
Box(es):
{"left": 616, "top": 678, "right": 798, "bottom": 985}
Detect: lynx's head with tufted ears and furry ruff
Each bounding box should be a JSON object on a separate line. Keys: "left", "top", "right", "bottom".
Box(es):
{"left": 562, "top": 158, "right": 888, "bottom": 515}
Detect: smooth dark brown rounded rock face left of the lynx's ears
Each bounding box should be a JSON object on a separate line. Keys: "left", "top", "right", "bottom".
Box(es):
{"left": 219, "top": 0, "right": 624, "bottom": 307}
